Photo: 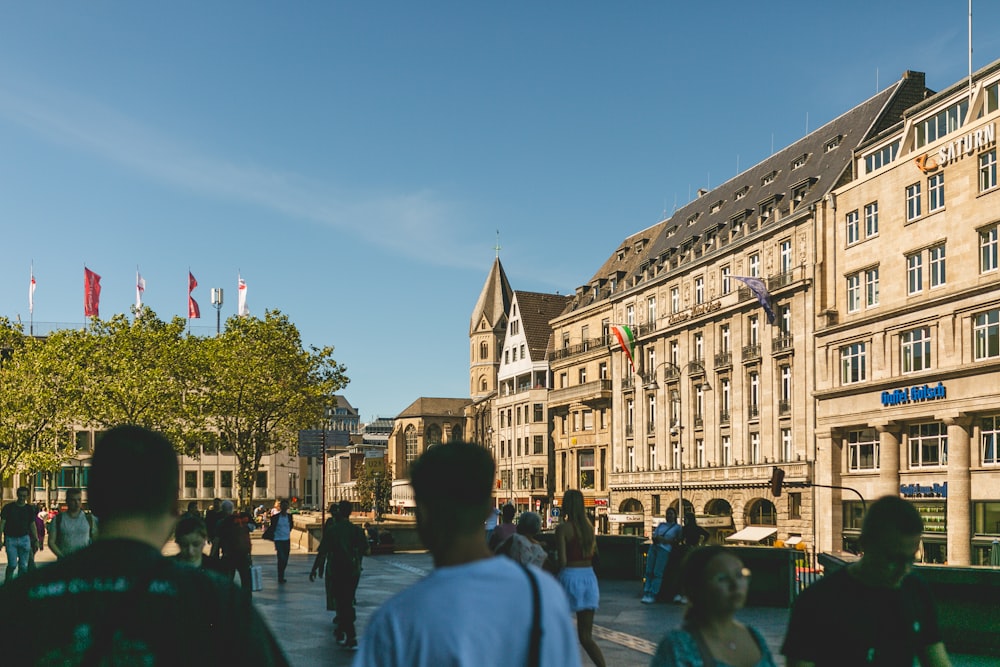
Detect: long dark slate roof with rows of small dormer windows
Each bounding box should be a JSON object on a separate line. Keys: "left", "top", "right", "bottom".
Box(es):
{"left": 563, "top": 72, "right": 929, "bottom": 314}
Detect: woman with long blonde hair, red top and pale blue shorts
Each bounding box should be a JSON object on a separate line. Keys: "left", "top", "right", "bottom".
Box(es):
{"left": 556, "top": 489, "right": 604, "bottom": 667}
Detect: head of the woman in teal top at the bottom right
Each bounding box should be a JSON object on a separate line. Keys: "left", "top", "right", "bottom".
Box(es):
{"left": 681, "top": 546, "right": 750, "bottom": 623}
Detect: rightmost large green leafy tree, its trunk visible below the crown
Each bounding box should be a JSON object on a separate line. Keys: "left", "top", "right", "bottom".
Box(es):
{"left": 198, "top": 310, "right": 349, "bottom": 507}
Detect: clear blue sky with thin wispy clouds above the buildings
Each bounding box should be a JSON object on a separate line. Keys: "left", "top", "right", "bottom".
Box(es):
{"left": 0, "top": 0, "right": 1000, "bottom": 420}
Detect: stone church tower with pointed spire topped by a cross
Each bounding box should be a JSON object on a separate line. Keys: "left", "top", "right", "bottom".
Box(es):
{"left": 469, "top": 256, "right": 513, "bottom": 401}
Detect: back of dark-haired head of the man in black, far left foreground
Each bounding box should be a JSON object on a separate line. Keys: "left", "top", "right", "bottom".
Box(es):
{"left": 87, "top": 426, "right": 178, "bottom": 524}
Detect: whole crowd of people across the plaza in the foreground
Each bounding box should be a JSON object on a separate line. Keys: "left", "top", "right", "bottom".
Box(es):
{"left": 0, "top": 426, "right": 950, "bottom": 667}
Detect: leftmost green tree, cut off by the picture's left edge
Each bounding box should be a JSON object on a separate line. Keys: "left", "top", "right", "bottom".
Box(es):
{"left": 0, "top": 318, "right": 76, "bottom": 477}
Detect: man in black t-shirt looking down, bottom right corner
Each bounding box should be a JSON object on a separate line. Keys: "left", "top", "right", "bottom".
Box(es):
{"left": 782, "top": 496, "right": 951, "bottom": 667}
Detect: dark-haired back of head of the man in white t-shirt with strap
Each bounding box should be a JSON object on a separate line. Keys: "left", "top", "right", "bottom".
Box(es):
{"left": 410, "top": 442, "right": 496, "bottom": 551}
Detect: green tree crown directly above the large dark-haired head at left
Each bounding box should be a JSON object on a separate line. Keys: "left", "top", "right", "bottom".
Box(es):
{"left": 64, "top": 308, "right": 206, "bottom": 454}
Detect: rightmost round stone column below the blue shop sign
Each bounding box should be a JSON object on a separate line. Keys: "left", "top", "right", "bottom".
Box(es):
{"left": 944, "top": 416, "right": 972, "bottom": 565}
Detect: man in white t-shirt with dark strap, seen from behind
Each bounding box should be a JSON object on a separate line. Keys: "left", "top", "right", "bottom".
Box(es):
{"left": 354, "top": 442, "right": 580, "bottom": 667}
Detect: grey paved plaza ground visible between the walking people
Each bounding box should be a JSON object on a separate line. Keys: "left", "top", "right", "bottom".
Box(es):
{"left": 0, "top": 539, "right": 1000, "bottom": 667}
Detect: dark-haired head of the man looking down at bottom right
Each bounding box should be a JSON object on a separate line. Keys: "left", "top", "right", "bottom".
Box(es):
{"left": 860, "top": 496, "right": 924, "bottom": 588}
